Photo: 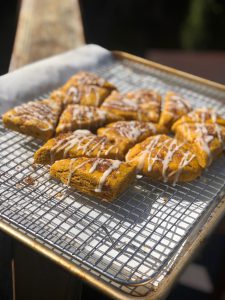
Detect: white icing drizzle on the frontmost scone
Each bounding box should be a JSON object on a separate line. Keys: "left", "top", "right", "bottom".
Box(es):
{"left": 67, "top": 158, "right": 122, "bottom": 193}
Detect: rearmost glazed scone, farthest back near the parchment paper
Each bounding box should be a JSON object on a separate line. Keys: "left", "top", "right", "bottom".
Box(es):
{"left": 51, "top": 72, "right": 116, "bottom": 106}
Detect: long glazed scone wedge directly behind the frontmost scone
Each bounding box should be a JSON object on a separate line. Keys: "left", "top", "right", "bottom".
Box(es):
{"left": 34, "top": 130, "right": 126, "bottom": 165}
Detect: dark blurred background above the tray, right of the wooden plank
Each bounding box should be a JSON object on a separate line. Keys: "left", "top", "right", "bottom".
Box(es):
{"left": 80, "top": 0, "right": 225, "bottom": 55}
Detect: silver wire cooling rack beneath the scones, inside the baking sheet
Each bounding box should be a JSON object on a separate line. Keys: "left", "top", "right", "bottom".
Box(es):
{"left": 0, "top": 59, "right": 225, "bottom": 296}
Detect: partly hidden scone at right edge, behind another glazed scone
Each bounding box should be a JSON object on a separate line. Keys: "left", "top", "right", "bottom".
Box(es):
{"left": 172, "top": 107, "right": 225, "bottom": 131}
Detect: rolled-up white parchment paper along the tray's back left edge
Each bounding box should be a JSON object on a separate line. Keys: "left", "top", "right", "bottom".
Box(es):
{"left": 0, "top": 45, "right": 112, "bottom": 114}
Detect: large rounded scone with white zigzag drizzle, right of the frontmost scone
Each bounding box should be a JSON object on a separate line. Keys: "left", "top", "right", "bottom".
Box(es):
{"left": 126, "top": 135, "right": 201, "bottom": 184}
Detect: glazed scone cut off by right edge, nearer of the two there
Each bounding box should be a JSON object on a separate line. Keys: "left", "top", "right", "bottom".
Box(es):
{"left": 176, "top": 123, "right": 225, "bottom": 168}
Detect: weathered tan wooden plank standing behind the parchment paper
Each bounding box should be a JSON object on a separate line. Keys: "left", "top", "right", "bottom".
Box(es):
{"left": 10, "top": 0, "right": 84, "bottom": 70}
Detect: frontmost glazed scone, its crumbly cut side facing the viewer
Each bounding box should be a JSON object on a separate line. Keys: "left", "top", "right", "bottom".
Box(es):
{"left": 50, "top": 157, "right": 135, "bottom": 201}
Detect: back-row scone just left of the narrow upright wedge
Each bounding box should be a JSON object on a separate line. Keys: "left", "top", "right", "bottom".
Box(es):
{"left": 101, "top": 89, "right": 161, "bottom": 123}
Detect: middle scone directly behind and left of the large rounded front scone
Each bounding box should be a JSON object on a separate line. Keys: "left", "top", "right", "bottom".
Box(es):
{"left": 97, "top": 121, "right": 167, "bottom": 152}
